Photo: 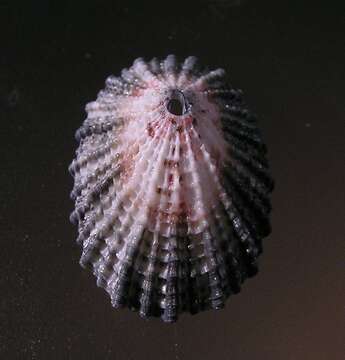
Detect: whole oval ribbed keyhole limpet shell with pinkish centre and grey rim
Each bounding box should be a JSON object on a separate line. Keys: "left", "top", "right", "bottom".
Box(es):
{"left": 69, "top": 55, "right": 273, "bottom": 322}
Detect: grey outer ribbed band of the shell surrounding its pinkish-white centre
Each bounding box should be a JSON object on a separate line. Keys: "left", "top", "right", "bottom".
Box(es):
{"left": 69, "top": 55, "right": 273, "bottom": 322}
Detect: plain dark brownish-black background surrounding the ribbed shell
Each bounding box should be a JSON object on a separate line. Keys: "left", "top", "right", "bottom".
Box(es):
{"left": 0, "top": 0, "right": 345, "bottom": 360}
